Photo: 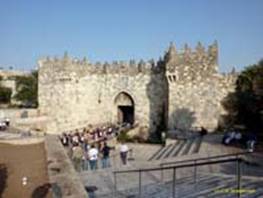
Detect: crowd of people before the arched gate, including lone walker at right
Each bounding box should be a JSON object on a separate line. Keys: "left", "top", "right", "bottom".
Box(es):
{"left": 60, "top": 125, "right": 129, "bottom": 171}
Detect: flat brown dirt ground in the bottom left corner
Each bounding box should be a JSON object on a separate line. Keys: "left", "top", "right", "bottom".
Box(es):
{"left": 0, "top": 142, "right": 51, "bottom": 198}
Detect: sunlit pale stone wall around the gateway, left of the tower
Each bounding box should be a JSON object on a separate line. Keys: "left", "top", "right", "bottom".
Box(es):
{"left": 39, "top": 52, "right": 167, "bottom": 132}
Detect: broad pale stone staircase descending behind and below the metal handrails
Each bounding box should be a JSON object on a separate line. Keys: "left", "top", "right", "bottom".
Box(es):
{"left": 79, "top": 137, "right": 263, "bottom": 198}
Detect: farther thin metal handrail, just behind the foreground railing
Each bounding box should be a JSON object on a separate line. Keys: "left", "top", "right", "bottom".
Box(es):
{"left": 160, "top": 151, "right": 252, "bottom": 167}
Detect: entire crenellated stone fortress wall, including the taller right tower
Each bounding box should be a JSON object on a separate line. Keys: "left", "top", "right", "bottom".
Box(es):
{"left": 39, "top": 43, "right": 235, "bottom": 133}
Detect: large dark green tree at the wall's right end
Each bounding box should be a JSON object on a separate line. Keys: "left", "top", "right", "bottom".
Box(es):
{"left": 223, "top": 60, "right": 263, "bottom": 133}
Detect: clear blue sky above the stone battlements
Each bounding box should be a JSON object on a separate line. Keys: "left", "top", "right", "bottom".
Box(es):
{"left": 0, "top": 0, "right": 263, "bottom": 71}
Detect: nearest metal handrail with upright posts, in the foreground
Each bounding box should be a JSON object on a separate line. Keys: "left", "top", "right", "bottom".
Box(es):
{"left": 113, "top": 157, "right": 243, "bottom": 198}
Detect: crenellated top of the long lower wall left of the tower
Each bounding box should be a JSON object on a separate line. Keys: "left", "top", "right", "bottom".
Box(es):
{"left": 38, "top": 53, "right": 163, "bottom": 76}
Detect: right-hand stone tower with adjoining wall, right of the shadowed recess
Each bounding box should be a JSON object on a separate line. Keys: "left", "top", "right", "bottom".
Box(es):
{"left": 164, "top": 42, "right": 236, "bottom": 130}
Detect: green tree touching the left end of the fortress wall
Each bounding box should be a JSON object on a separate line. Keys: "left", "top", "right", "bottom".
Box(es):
{"left": 14, "top": 71, "right": 38, "bottom": 107}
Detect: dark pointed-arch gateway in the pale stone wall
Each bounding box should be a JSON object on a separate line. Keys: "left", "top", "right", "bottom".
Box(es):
{"left": 114, "top": 92, "right": 134, "bottom": 124}
